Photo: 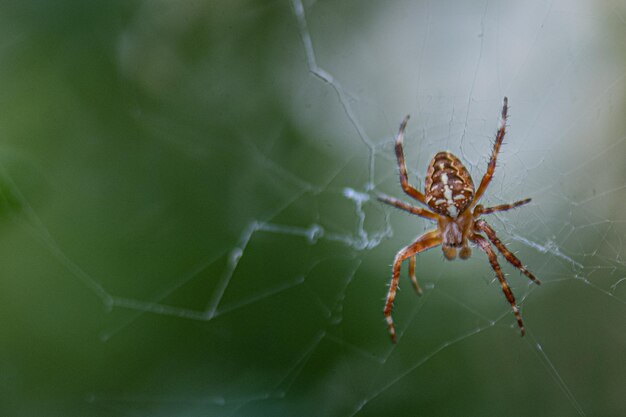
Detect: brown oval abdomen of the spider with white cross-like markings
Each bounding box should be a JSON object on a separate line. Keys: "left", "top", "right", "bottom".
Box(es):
{"left": 424, "top": 152, "right": 474, "bottom": 218}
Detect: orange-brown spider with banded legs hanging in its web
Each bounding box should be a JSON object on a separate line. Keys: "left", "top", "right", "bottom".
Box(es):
{"left": 378, "top": 97, "right": 540, "bottom": 343}
